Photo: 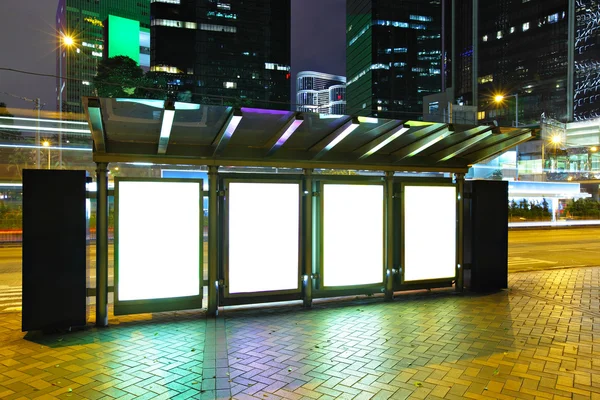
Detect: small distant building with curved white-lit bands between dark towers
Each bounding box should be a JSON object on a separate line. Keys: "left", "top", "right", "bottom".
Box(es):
{"left": 296, "top": 71, "right": 346, "bottom": 115}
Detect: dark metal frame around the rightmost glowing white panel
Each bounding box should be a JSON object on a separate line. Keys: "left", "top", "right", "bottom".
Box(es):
{"left": 394, "top": 181, "right": 459, "bottom": 287}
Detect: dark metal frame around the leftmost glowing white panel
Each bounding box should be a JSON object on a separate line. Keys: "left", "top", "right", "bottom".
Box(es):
{"left": 114, "top": 177, "right": 204, "bottom": 315}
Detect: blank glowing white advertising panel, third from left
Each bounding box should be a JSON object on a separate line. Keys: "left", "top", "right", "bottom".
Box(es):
{"left": 323, "top": 184, "right": 384, "bottom": 287}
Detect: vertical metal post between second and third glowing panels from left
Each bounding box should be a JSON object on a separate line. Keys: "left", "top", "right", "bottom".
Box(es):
{"left": 302, "top": 169, "right": 313, "bottom": 308}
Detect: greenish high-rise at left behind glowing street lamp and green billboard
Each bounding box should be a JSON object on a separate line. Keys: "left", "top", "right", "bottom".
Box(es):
{"left": 56, "top": 0, "right": 150, "bottom": 118}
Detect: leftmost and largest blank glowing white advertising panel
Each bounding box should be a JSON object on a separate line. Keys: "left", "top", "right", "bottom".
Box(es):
{"left": 115, "top": 180, "right": 202, "bottom": 308}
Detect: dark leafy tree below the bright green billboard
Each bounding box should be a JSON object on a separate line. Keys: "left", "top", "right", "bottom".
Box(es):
{"left": 94, "top": 56, "right": 147, "bottom": 97}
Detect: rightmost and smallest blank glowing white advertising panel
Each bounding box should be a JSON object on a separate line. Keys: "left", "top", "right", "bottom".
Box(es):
{"left": 403, "top": 186, "right": 456, "bottom": 281}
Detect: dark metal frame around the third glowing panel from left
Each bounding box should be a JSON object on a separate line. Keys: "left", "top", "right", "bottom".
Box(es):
{"left": 313, "top": 176, "right": 386, "bottom": 298}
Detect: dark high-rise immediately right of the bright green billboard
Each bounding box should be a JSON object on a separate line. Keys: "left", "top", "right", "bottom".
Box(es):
{"left": 150, "top": 0, "right": 291, "bottom": 109}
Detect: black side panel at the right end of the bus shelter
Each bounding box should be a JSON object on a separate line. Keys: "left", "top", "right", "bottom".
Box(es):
{"left": 465, "top": 181, "right": 508, "bottom": 292}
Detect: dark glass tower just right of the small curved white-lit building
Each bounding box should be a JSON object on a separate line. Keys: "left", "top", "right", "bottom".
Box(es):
{"left": 346, "top": 0, "right": 444, "bottom": 119}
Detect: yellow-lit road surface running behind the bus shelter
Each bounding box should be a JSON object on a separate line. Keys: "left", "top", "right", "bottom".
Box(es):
{"left": 0, "top": 228, "right": 600, "bottom": 312}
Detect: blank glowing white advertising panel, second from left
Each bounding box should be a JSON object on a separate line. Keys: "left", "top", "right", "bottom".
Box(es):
{"left": 227, "top": 182, "right": 300, "bottom": 294}
